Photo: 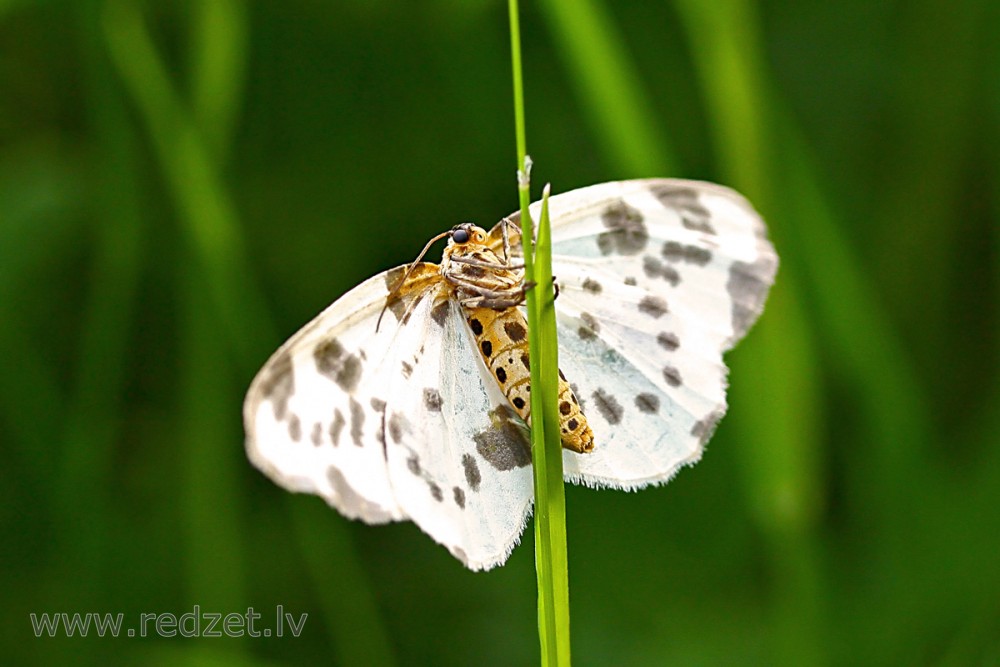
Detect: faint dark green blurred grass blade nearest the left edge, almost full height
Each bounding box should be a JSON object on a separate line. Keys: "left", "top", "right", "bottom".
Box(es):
{"left": 47, "top": 2, "right": 146, "bottom": 628}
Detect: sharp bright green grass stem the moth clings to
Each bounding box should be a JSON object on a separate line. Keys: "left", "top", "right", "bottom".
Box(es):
{"left": 508, "top": 0, "right": 570, "bottom": 666}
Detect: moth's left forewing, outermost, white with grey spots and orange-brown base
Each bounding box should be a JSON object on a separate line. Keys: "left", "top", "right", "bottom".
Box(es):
{"left": 243, "top": 264, "right": 440, "bottom": 523}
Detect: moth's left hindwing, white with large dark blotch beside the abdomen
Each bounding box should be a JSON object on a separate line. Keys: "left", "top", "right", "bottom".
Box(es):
{"left": 386, "top": 300, "right": 533, "bottom": 570}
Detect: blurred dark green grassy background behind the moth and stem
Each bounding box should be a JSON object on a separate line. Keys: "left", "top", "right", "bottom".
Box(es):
{"left": 0, "top": 0, "right": 1000, "bottom": 665}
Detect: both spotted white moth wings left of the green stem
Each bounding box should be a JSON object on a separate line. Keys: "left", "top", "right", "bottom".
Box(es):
{"left": 244, "top": 264, "right": 531, "bottom": 569}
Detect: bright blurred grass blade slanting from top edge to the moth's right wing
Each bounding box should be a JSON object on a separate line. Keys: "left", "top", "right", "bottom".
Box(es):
{"left": 539, "top": 0, "right": 678, "bottom": 178}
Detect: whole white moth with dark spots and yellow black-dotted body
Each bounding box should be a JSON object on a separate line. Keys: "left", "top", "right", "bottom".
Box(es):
{"left": 243, "top": 179, "right": 778, "bottom": 570}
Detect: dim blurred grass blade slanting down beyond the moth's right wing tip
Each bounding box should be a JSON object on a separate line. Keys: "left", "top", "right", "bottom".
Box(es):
{"left": 779, "top": 122, "right": 933, "bottom": 486}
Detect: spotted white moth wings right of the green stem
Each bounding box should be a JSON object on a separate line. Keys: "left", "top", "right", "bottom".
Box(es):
{"left": 500, "top": 179, "right": 778, "bottom": 489}
